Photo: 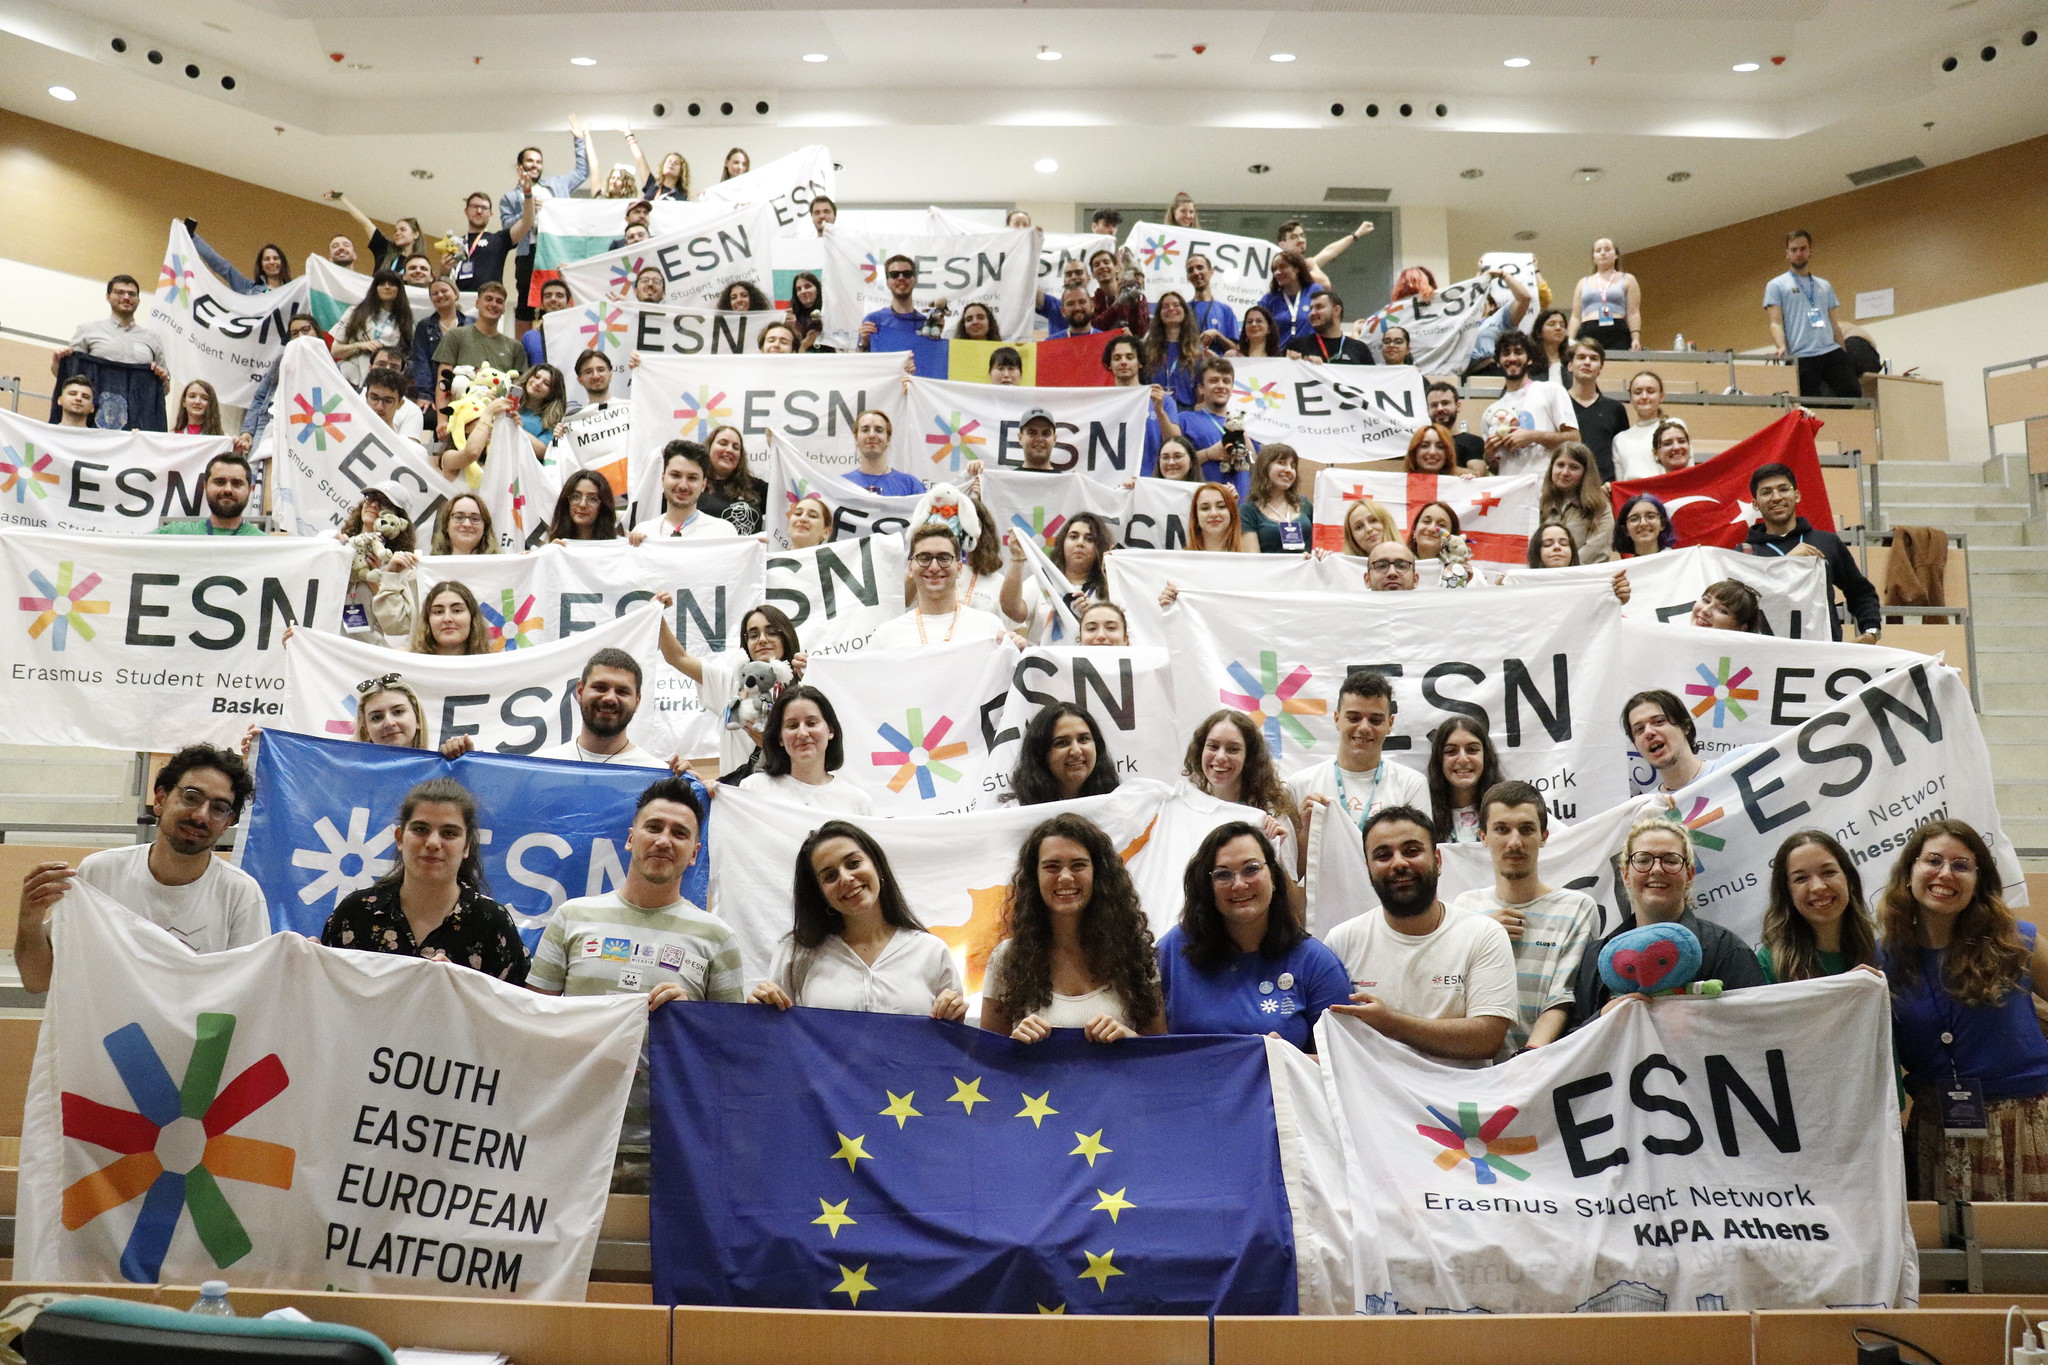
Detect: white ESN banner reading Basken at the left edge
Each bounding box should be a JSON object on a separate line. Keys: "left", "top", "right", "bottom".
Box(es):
{"left": 0, "top": 528, "right": 348, "bottom": 753}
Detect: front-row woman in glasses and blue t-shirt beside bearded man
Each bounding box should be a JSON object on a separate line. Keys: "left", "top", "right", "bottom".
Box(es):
{"left": 1159, "top": 821, "right": 1352, "bottom": 1052}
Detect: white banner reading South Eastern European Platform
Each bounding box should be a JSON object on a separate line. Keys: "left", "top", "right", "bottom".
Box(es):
{"left": 14, "top": 884, "right": 647, "bottom": 1302}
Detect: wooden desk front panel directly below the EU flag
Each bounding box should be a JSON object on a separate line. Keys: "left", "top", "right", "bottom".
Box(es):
{"left": 663, "top": 1308, "right": 1204, "bottom": 1365}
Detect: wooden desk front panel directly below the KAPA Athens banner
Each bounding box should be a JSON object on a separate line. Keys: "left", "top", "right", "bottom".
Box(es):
{"left": 1204, "top": 1314, "right": 1753, "bottom": 1365}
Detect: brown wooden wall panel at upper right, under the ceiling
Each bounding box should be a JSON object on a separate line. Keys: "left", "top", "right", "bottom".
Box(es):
{"left": 1630, "top": 137, "right": 2048, "bottom": 358}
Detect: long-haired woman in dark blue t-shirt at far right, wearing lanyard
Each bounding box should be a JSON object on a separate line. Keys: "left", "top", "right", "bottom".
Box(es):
{"left": 1878, "top": 821, "right": 2048, "bottom": 1201}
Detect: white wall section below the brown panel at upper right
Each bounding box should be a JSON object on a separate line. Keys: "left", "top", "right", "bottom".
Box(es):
{"left": 1867, "top": 284, "right": 2048, "bottom": 465}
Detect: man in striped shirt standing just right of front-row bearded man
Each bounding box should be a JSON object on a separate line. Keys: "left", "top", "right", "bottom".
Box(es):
{"left": 1452, "top": 782, "right": 1599, "bottom": 1060}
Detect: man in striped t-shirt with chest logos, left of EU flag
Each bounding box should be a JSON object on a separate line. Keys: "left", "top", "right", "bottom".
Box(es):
{"left": 526, "top": 778, "right": 741, "bottom": 1193}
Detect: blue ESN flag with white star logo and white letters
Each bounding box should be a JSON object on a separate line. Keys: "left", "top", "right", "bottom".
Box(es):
{"left": 236, "top": 731, "right": 711, "bottom": 952}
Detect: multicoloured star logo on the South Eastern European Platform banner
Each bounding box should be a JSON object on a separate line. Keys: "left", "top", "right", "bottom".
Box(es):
{"left": 63, "top": 1015, "right": 299, "bottom": 1285}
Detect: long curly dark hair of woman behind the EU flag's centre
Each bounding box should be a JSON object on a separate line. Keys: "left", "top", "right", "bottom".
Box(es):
{"left": 989, "top": 814, "right": 1159, "bottom": 1029}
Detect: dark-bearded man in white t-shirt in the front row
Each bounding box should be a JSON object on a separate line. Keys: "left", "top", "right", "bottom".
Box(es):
{"left": 1323, "top": 806, "right": 1518, "bottom": 1066}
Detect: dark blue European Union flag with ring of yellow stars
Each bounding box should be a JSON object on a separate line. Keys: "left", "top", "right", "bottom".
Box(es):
{"left": 649, "top": 1003, "right": 1296, "bottom": 1314}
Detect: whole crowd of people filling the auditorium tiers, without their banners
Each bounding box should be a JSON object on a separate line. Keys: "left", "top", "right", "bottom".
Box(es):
{"left": 18, "top": 141, "right": 1998, "bottom": 1199}
